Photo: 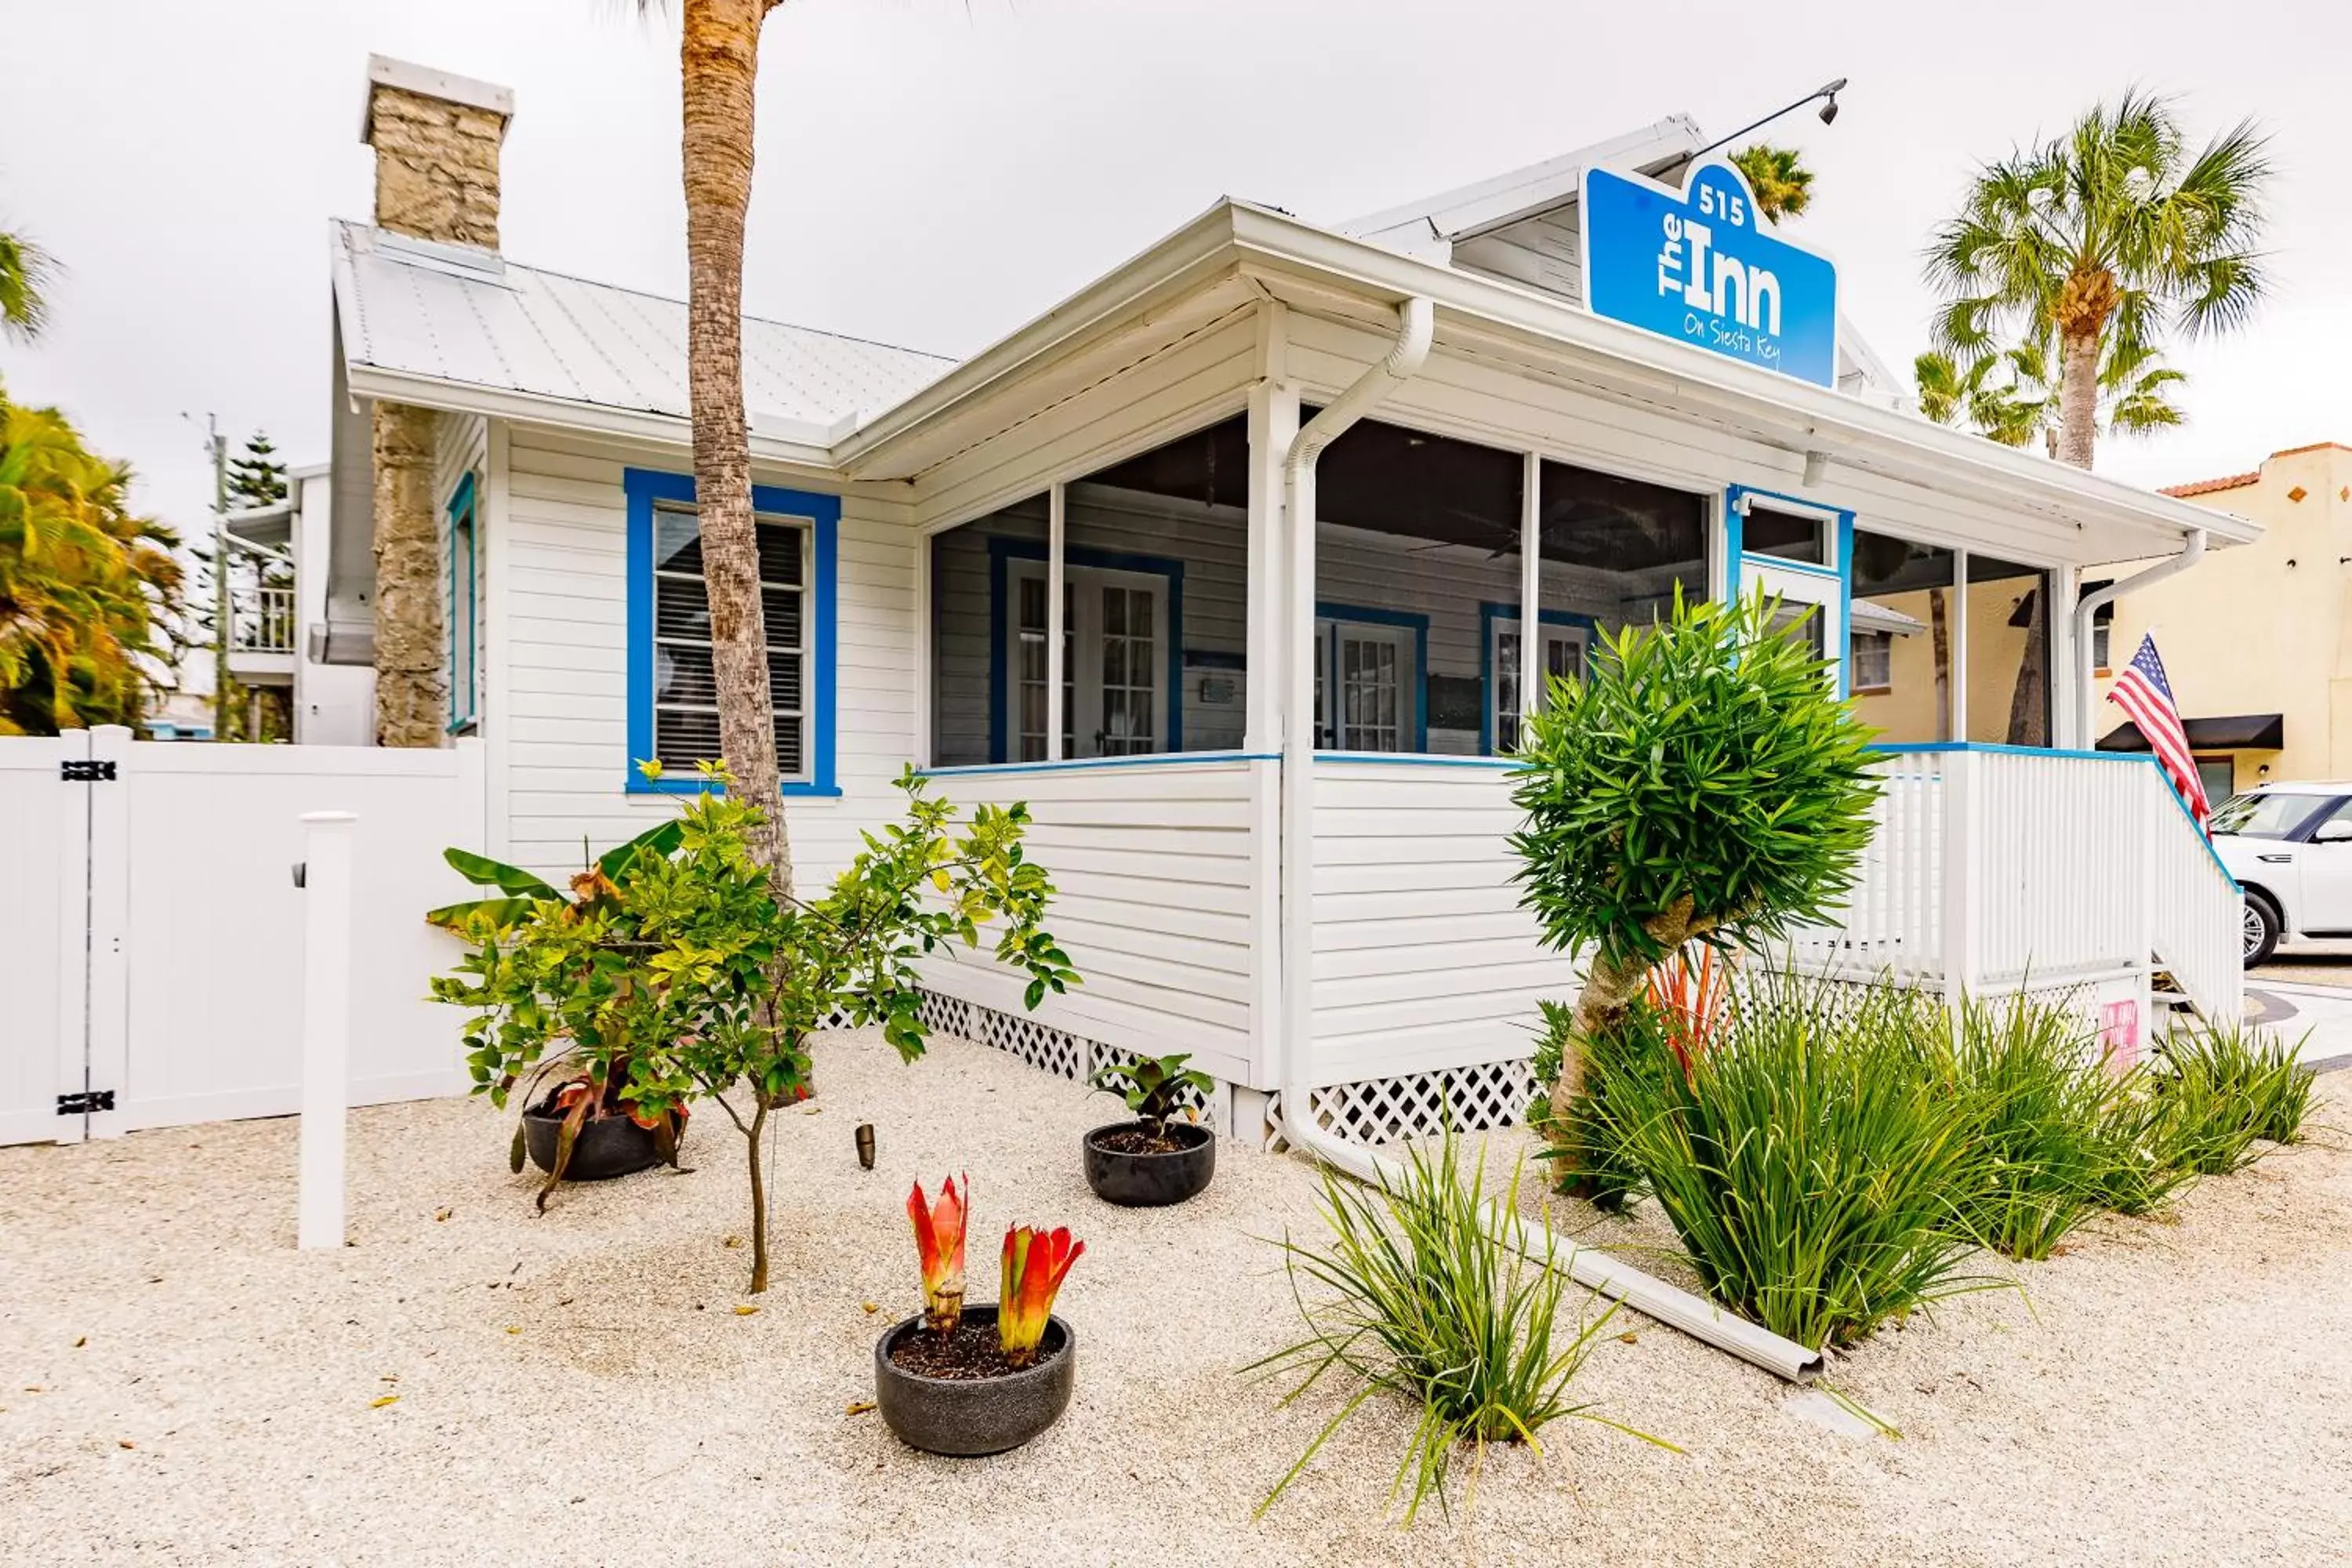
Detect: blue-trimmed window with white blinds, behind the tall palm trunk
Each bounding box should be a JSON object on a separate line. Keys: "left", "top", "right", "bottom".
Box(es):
{"left": 623, "top": 468, "right": 842, "bottom": 794}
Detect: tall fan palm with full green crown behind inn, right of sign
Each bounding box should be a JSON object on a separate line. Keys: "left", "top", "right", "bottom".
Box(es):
{"left": 1926, "top": 92, "right": 2272, "bottom": 468}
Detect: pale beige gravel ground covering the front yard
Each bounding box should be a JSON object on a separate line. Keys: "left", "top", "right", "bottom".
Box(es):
{"left": 0, "top": 1036, "right": 2352, "bottom": 1568}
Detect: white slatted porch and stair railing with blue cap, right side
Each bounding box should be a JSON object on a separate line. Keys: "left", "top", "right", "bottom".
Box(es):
{"left": 1795, "top": 746, "right": 2244, "bottom": 1018}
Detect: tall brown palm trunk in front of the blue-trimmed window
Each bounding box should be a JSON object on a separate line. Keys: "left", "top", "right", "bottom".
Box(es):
{"left": 680, "top": 0, "right": 793, "bottom": 893}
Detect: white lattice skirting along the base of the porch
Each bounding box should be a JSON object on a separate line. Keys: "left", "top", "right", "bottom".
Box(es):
{"left": 922, "top": 992, "right": 1536, "bottom": 1147}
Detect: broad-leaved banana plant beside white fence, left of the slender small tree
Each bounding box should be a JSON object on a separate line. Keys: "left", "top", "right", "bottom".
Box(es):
{"left": 426, "top": 818, "right": 687, "bottom": 1213}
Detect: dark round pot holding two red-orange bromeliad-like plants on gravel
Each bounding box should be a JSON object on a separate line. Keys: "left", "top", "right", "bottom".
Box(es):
{"left": 875, "top": 1178, "right": 1087, "bottom": 1455}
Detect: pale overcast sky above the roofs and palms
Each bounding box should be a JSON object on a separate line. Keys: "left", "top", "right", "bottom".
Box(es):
{"left": 0, "top": 0, "right": 2352, "bottom": 524}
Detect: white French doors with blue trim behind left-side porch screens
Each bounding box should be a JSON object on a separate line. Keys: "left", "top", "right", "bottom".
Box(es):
{"left": 1004, "top": 562, "right": 1171, "bottom": 762}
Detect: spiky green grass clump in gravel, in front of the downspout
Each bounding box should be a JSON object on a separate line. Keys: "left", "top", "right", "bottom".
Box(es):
{"left": 1244, "top": 1131, "right": 1656, "bottom": 1523}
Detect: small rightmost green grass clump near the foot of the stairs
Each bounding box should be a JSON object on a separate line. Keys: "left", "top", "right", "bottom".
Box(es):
{"left": 2154, "top": 1025, "right": 2312, "bottom": 1175}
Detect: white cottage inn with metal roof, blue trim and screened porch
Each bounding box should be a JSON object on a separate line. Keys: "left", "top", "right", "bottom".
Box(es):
{"left": 320, "top": 61, "right": 2253, "bottom": 1138}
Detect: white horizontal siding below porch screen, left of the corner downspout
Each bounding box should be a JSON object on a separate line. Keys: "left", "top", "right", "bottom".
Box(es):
{"left": 924, "top": 760, "right": 1275, "bottom": 1081}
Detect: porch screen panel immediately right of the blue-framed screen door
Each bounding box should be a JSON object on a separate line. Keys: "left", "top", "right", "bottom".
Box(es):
{"left": 1846, "top": 529, "right": 1959, "bottom": 746}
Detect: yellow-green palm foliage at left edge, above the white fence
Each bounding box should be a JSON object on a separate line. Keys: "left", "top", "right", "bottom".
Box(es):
{"left": 0, "top": 388, "right": 181, "bottom": 736}
